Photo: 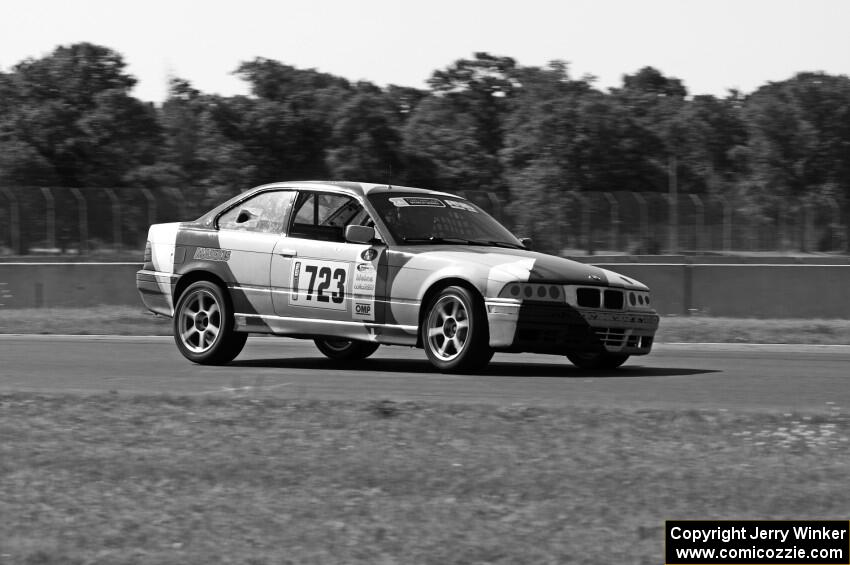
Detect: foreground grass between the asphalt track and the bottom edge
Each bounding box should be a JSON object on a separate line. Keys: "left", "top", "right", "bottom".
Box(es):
{"left": 0, "top": 394, "right": 850, "bottom": 565}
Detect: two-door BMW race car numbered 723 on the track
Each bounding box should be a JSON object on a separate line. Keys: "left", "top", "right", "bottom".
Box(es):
{"left": 136, "top": 181, "right": 658, "bottom": 372}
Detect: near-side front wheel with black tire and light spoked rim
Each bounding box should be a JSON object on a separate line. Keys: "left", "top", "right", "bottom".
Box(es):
{"left": 419, "top": 286, "right": 493, "bottom": 372}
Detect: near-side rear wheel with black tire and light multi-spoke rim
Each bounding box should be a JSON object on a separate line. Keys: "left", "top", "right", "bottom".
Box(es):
{"left": 174, "top": 281, "right": 248, "bottom": 365}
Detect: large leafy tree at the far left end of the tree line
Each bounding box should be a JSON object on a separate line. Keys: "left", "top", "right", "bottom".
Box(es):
{"left": 0, "top": 43, "right": 160, "bottom": 186}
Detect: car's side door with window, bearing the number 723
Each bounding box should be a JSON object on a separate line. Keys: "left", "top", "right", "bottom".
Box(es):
{"left": 271, "top": 191, "right": 386, "bottom": 337}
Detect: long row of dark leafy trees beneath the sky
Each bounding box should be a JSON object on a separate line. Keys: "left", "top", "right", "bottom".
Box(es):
{"left": 0, "top": 43, "right": 850, "bottom": 252}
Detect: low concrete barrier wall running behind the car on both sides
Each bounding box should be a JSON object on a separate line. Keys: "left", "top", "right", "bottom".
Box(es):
{"left": 0, "top": 263, "right": 850, "bottom": 319}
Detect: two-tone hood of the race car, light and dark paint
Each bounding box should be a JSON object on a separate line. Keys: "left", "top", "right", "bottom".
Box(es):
{"left": 392, "top": 245, "right": 647, "bottom": 290}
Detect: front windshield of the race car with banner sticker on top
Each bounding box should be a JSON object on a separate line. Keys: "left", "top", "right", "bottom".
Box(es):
{"left": 369, "top": 191, "right": 524, "bottom": 249}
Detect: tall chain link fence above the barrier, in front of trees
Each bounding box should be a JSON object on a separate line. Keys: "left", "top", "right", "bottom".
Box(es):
{"left": 0, "top": 186, "right": 848, "bottom": 257}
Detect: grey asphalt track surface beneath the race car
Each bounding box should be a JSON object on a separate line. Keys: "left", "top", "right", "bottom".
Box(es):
{"left": 0, "top": 335, "right": 850, "bottom": 413}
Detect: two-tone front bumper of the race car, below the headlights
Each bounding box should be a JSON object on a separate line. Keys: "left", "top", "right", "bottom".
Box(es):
{"left": 485, "top": 299, "right": 659, "bottom": 355}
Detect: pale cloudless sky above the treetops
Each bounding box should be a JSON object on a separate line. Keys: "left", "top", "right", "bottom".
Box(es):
{"left": 0, "top": 0, "right": 850, "bottom": 102}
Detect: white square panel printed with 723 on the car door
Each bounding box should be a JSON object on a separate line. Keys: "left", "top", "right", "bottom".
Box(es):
{"left": 289, "top": 260, "right": 350, "bottom": 310}
